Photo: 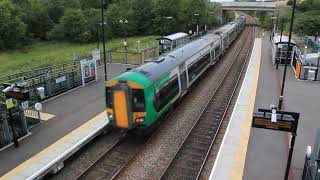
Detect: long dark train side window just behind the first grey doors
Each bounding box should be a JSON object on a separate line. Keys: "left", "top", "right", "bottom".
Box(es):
{"left": 188, "top": 53, "right": 210, "bottom": 82}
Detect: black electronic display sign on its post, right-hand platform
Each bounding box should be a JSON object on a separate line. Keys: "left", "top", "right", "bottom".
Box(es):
{"left": 252, "top": 109, "right": 300, "bottom": 180}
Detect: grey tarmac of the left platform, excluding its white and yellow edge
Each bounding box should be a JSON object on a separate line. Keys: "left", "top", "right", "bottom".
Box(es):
{"left": 0, "top": 64, "right": 132, "bottom": 176}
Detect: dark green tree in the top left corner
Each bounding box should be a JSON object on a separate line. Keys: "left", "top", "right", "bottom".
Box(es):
{"left": 0, "top": 0, "right": 26, "bottom": 49}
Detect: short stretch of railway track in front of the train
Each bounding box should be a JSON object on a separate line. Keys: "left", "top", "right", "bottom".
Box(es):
{"left": 76, "top": 134, "right": 148, "bottom": 180}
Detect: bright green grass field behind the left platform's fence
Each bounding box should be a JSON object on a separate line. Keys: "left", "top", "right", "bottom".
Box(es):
{"left": 0, "top": 36, "right": 156, "bottom": 76}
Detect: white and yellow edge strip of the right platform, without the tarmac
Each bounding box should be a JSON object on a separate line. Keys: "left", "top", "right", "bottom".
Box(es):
{"left": 209, "top": 38, "right": 262, "bottom": 180}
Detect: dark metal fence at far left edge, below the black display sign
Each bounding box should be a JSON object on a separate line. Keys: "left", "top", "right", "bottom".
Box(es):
{"left": 0, "top": 108, "right": 28, "bottom": 148}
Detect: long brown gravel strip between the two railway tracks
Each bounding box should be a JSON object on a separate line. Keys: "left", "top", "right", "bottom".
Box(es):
{"left": 118, "top": 27, "right": 248, "bottom": 179}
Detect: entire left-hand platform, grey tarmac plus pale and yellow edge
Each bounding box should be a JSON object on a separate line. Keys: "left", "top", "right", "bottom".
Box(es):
{"left": 0, "top": 64, "right": 132, "bottom": 179}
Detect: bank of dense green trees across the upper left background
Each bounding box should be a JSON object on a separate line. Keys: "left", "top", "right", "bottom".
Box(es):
{"left": 0, "top": 0, "right": 220, "bottom": 49}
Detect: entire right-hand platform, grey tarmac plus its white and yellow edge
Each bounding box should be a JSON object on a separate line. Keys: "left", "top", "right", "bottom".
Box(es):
{"left": 210, "top": 32, "right": 320, "bottom": 180}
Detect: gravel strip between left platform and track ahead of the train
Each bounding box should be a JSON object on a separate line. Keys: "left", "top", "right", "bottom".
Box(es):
{"left": 51, "top": 133, "right": 119, "bottom": 179}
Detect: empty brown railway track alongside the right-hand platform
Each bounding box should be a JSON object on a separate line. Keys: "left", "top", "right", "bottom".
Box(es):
{"left": 160, "top": 17, "right": 253, "bottom": 179}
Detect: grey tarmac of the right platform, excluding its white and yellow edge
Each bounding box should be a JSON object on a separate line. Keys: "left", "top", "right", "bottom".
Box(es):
{"left": 243, "top": 32, "right": 320, "bottom": 180}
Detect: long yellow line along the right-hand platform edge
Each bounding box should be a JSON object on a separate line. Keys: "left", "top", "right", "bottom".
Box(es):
{"left": 230, "top": 38, "right": 261, "bottom": 180}
